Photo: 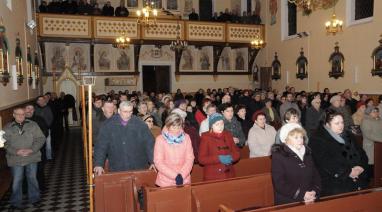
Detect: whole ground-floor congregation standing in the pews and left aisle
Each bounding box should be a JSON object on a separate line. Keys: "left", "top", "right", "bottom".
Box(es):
{"left": 4, "top": 87, "right": 382, "bottom": 207}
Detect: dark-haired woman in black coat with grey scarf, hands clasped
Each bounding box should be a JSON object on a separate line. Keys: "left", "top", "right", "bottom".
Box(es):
{"left": 309, "top": 109, "right": 369, "bottom": 196}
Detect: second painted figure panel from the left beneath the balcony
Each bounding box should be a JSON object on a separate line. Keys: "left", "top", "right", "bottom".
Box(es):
{"left": 69, "top": 43, "right": 90, "bottom": 73}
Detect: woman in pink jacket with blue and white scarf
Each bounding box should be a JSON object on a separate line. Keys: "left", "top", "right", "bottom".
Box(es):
{"left": 154, "top": 113, "right": 194, "bottom": 187}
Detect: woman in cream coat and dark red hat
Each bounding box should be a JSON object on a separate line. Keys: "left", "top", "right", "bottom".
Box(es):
{"left": 248, "top": 111, "right": 276, "bottom": 158}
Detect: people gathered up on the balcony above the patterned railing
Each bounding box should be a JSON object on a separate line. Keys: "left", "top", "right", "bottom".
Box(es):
{"left": 38, "top": 0, "right": 261, "bottom": 24}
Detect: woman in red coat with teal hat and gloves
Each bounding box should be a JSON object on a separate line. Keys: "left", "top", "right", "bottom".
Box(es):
{"left": 199, "top": 113, "right": 240, "bottom": 180}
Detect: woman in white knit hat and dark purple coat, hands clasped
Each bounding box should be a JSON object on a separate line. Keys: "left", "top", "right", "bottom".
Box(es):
{"left": 272, "top": 123, "right": 321, "bottom": 205}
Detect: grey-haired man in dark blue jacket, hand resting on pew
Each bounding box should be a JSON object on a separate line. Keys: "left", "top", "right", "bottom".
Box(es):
{"left": 94, "top": 101, "right": 154, "bottom": 175}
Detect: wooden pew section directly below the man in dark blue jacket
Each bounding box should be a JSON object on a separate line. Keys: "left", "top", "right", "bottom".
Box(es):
{"left": 94, "top": 170, "right": 156, "bottom": 212}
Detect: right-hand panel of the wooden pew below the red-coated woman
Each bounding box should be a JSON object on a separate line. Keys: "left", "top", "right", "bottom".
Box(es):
{"left": 191, "top": 173, "right": 274, "bottom": 212}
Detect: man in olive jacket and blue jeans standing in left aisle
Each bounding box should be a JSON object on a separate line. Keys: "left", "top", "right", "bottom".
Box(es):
{"left": 4, "top": 108, "right": 45, "bottom": 209}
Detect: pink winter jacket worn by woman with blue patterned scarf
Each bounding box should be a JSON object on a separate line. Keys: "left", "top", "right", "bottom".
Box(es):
{"left": 154, "top": 128, "right": 194, "bottom": 187}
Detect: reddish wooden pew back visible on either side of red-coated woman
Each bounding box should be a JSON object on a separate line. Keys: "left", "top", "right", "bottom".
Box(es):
{"left": 191, "top": 157, "right": 272, "bottom": 183}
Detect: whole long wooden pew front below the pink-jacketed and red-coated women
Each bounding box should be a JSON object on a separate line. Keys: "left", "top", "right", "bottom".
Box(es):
{"left": 144, "top": 173, "right": 274, "bottom": 212}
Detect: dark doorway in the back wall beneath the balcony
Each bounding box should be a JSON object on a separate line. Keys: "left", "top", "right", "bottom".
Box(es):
{"left": 142, "top": 66, "right": 170, "bottom": 93}
